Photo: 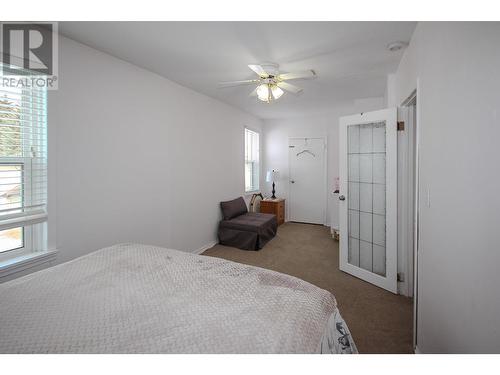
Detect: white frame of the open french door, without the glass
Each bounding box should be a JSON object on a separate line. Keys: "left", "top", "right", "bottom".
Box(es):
{"left": 339, "top": 107, "right": 398, "bottom": 293}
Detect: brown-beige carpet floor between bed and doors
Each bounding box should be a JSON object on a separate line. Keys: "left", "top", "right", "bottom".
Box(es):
{"left": 203, "top": 223, "right": 413, "bottom": 353}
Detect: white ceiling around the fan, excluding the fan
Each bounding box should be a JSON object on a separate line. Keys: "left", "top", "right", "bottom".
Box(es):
{"left": 59, "top": 22, "right": 416, "bottom": 118}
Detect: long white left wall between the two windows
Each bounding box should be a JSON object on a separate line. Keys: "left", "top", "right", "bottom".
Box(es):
{"left": 48, "top": 37, "right": 262, "bottom": 262}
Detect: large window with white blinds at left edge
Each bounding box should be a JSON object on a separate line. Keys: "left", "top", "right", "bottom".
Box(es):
{"left": 0, "top": 67, "right": 47, "bottom": 260}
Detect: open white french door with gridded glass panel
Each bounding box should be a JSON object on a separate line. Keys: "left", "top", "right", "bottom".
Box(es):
{"left": 339, "top": 108, "right": 397, "bottom": 293}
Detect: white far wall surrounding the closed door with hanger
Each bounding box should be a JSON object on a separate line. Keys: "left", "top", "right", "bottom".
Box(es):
{"left": 262, "top": 97, "right": 384, "bottom": 228}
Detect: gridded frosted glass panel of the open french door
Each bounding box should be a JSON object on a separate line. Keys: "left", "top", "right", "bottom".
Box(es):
{"left": 347, "top": 121, "right": 386, "bottom": 276}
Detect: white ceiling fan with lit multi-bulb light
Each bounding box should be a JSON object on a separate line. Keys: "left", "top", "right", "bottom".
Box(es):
{"left": 219, "top": 63, "right": 316, "bottom": 103}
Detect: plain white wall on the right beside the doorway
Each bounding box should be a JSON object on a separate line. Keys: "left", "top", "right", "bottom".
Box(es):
{"left": 387, "top": 22, "right": 500, "bottom": 353}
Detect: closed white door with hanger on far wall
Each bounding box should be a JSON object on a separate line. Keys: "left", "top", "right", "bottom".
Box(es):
{"left": 288, "top": 138, "right": 326, "bottom": 224}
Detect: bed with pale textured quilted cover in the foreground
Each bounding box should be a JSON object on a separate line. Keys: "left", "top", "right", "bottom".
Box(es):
{"left": 0, "top": 244, "right": 357, "bottom": 353}
